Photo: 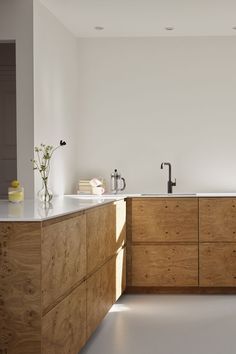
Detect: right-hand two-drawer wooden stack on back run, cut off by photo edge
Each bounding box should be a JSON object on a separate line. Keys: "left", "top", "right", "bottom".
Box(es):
{"left": 199, "top": 198, "right": 236, "bottom": 287}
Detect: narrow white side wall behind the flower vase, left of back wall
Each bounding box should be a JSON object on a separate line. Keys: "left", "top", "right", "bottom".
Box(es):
{"left": 34, "top": 0, "right": 78, "bottom": 195}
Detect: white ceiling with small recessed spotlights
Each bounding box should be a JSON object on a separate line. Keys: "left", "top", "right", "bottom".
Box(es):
{"left": 41, "top": 0, "right": 236, "bottom": 37}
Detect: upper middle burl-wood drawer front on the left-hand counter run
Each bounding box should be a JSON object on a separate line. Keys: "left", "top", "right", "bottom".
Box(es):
{"left": 86, "top": 204, "right": 116, "bottom": 273}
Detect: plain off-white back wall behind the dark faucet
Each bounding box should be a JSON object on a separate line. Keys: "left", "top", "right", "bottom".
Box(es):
{"left": 77, "top": 37, "right": 236, "bottom": 192}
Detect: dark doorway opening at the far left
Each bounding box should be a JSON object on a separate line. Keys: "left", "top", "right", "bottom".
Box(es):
{"left": 0, "top": 43, "right": 17, "bottom": 197}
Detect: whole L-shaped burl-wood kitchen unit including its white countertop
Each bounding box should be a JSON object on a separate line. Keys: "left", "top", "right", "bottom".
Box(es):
{"left": 0, "top": 193, "right": 236, "bottom": 354}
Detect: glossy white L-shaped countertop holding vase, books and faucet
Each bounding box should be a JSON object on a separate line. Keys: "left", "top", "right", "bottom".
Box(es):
{"left": 0, "top": 193, "right": 236, "bottom": 222}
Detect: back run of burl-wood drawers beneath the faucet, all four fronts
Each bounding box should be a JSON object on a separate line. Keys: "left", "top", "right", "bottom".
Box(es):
{"left": 127, "top": 197, "right": 236, "bottom": 291}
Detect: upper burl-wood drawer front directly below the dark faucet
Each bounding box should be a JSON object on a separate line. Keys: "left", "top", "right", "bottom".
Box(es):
{"left": 132, "top": 198, "right": 198, "bottom": 242}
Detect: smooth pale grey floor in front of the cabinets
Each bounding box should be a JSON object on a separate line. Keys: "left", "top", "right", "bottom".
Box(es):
{"left": 80, "top": 295, "right": 236, "bottom": 354}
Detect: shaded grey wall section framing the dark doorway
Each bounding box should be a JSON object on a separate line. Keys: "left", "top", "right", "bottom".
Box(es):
{"left": 0, "top": 0, "right": 34, "bottom": 197}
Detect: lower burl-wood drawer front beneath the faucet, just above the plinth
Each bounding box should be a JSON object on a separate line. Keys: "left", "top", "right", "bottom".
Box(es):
{"left": 132, "top": 244, "right": 198, "bottom": 286}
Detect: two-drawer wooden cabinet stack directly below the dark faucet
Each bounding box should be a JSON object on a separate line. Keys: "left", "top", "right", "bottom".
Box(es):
{"left": 127, "top": 197, "right": 198, "bottom": 287}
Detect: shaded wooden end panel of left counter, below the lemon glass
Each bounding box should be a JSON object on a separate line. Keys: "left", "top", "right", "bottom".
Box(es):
{"left": 0, "top": 222, "right": 41, "bottom": 354}
